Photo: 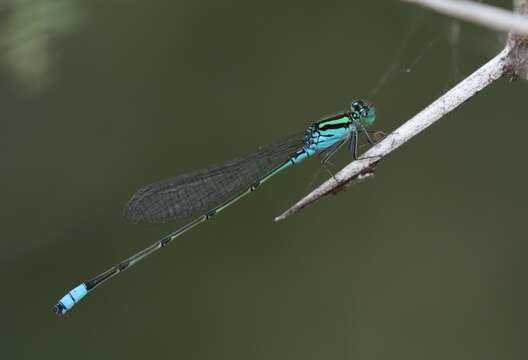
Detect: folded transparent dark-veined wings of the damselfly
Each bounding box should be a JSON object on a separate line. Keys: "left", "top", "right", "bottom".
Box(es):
{"left": 124, "top": 133, "right": 304, "bottom": 223}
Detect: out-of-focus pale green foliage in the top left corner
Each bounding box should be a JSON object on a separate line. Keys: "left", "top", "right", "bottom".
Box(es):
{"left": 0, "top": 0, "right": 80, "bottom": 93}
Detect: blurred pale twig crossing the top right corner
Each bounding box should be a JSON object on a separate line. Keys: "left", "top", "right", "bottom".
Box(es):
{"left": 403, "top": 0, "right": 528, "bottom": 36}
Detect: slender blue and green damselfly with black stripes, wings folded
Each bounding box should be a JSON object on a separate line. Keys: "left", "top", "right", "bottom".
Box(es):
{"left": 53, "top": 100, "right": 376, "bottom": 315}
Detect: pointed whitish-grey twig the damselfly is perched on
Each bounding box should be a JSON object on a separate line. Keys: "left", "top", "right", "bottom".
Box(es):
{"left": 275, "top": 0, "right": 528, "bottom": 221}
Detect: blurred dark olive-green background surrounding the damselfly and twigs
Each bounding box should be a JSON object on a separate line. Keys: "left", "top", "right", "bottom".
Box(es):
{"left": 0, "top": 0, "right": 528, "bottom": 360}
